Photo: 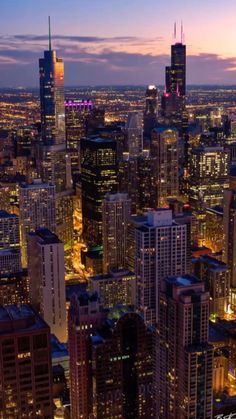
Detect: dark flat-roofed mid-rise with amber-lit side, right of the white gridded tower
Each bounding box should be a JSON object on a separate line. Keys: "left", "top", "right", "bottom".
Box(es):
{"left": 192, "top": 255, "right": 230, "bottom": 318}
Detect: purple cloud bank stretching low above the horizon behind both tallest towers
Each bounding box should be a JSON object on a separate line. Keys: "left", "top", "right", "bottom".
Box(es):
{"left": 0, "top": 35, "right": 236, "bottom": 86}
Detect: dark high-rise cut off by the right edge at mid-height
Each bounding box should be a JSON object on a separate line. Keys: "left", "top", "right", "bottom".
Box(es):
{"left": 223, "top": 189, "right": 236, "bottom": 309}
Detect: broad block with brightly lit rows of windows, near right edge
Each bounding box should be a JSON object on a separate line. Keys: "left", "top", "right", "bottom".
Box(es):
{"left": 188, "top": 146, "right": 229, "bottom": 211}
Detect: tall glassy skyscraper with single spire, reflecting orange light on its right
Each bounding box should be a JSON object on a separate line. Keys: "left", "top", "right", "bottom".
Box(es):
{"left": 39, "top": 18, "right": 65, "bottom": 145}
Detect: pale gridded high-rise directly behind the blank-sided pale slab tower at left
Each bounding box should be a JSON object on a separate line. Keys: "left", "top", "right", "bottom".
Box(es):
{"left": 19, "top": 179, "right": 56, "bottom": 266}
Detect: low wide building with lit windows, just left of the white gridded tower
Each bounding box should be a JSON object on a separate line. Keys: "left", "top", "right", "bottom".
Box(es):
{"left": 88, "top": 269, "right": 136, "bottom": 308}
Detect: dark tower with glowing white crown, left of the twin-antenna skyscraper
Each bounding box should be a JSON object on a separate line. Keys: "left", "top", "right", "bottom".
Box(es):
{"left": 143, "top": 85, "right": 158, "bottom": 139}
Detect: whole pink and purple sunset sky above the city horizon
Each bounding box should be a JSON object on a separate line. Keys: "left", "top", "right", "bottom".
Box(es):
{"left": 0, "top": 0, "right": 236, "bottom": 87}
